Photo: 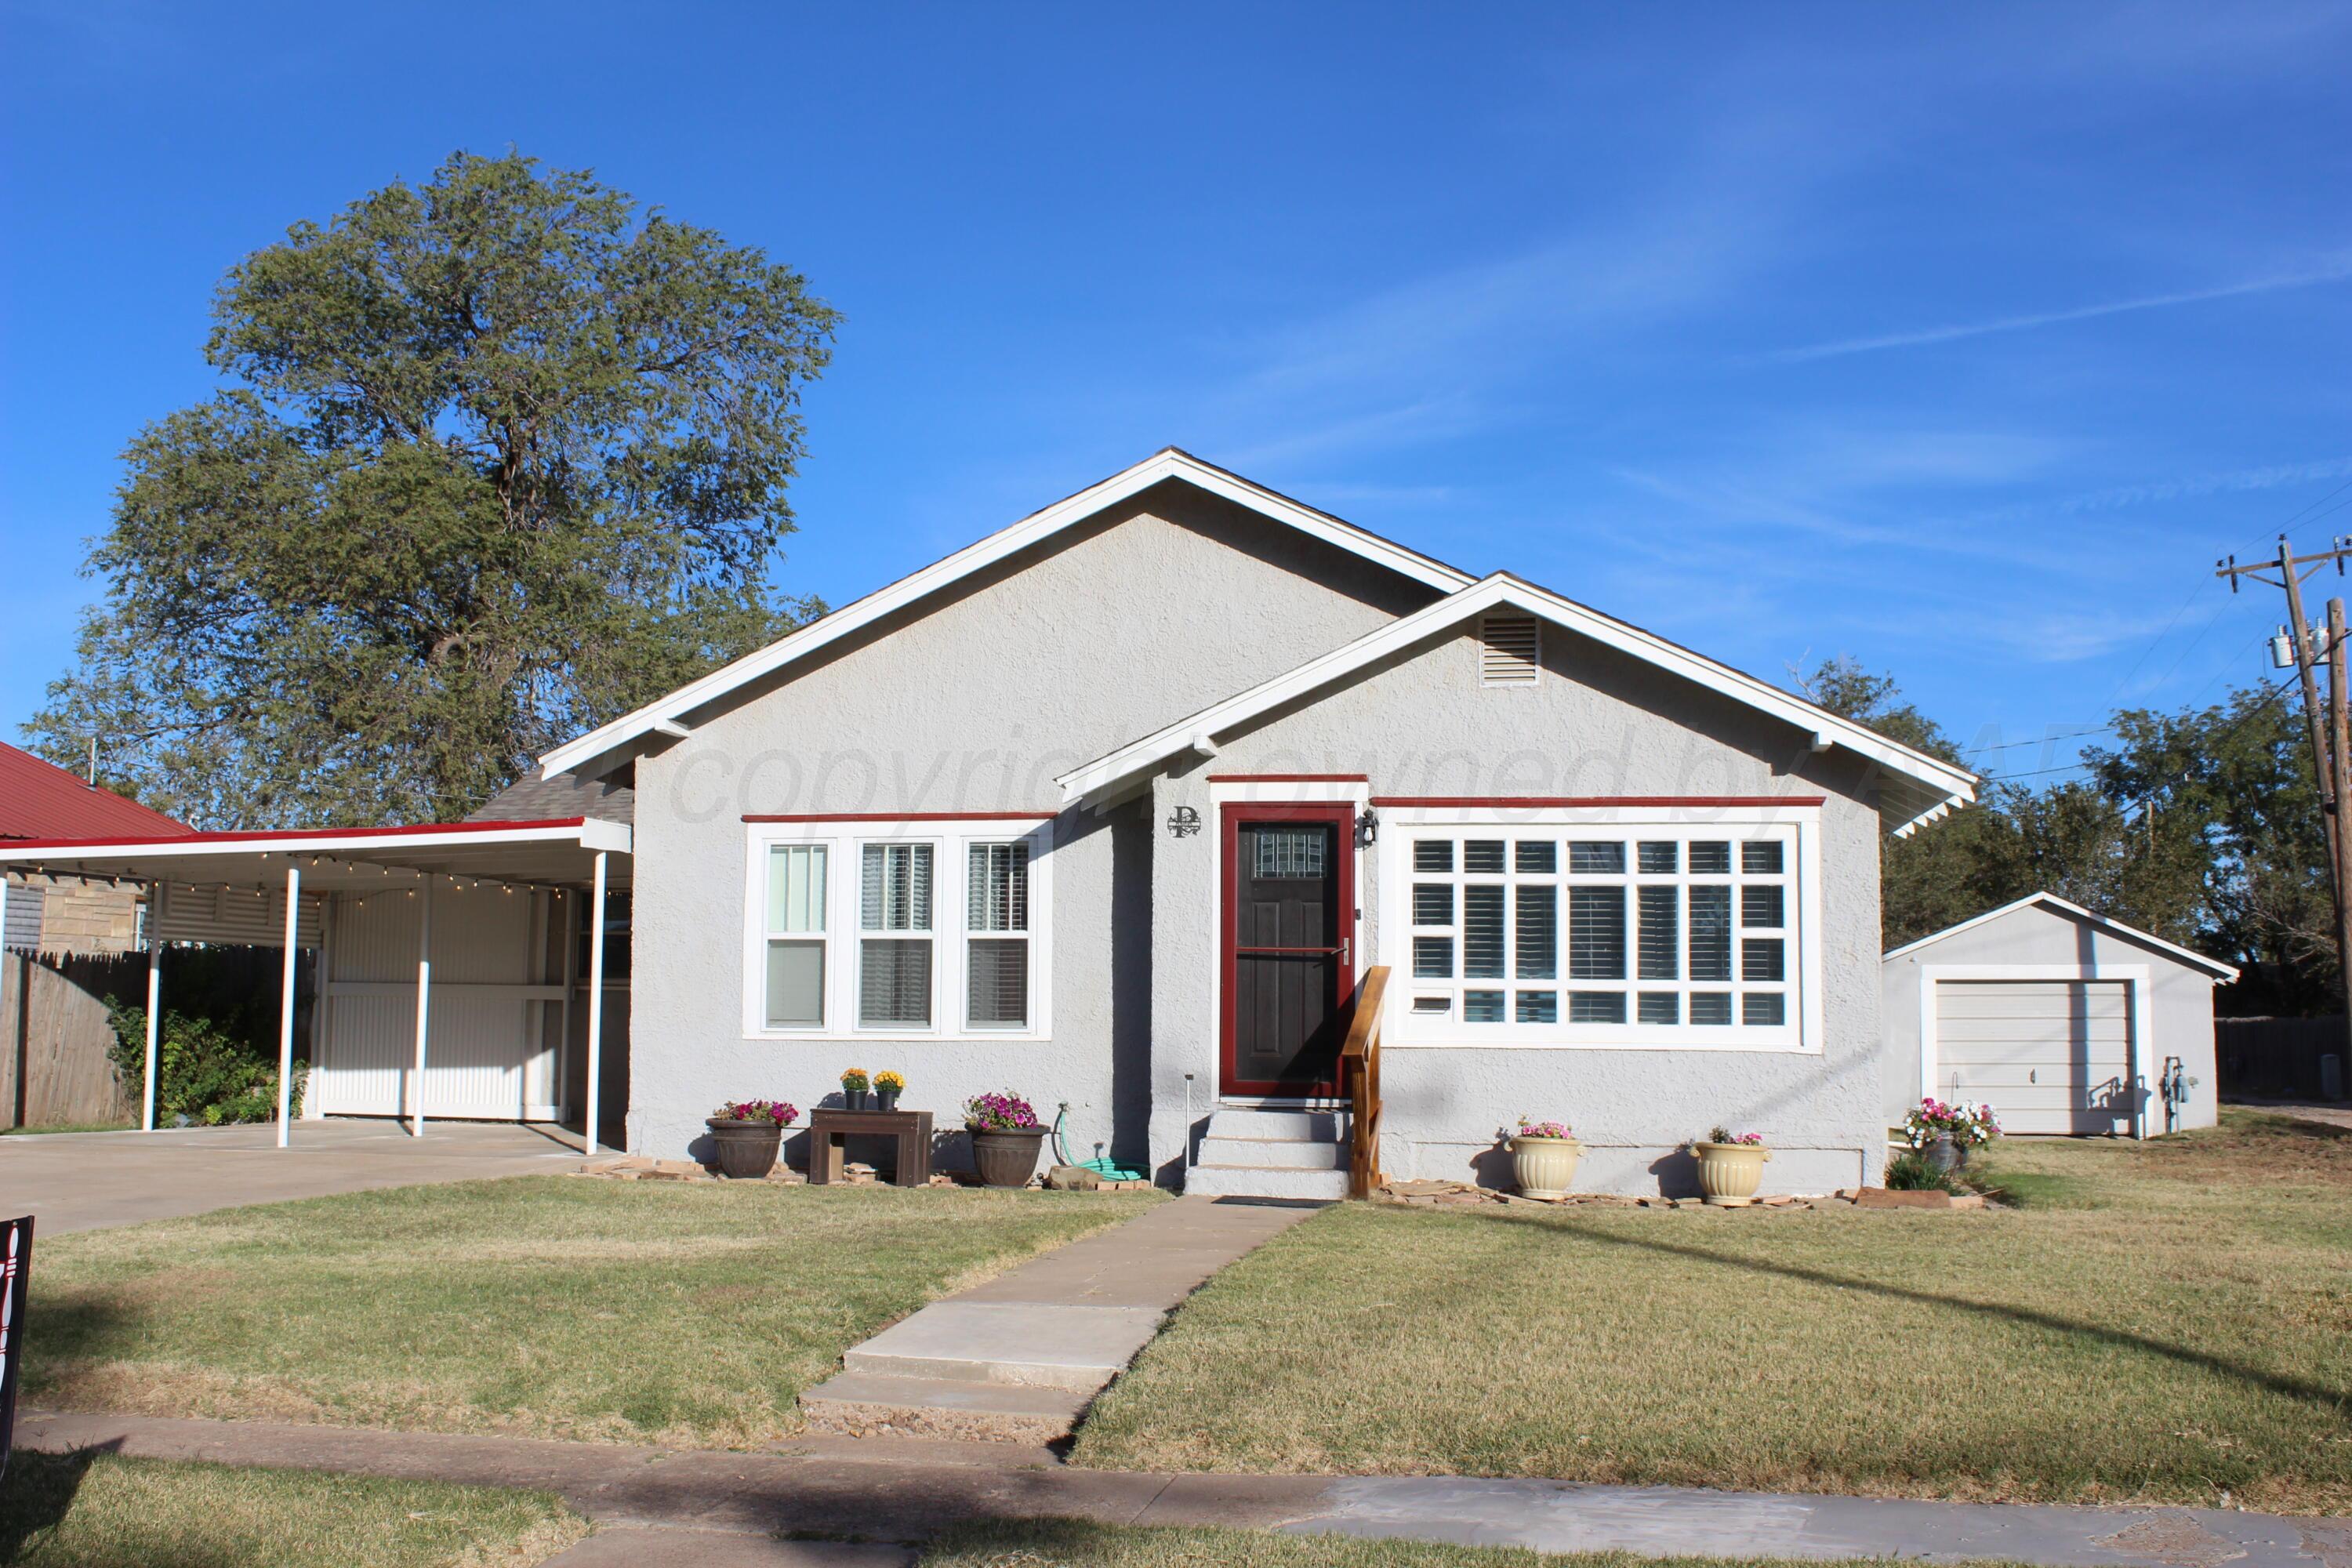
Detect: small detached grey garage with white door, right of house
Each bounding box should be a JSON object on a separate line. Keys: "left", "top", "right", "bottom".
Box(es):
{"left": 1879, "top": 893, "right": 2237, "bottom": 1138}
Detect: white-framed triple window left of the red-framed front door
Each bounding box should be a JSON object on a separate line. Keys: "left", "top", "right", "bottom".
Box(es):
{"left": 743, "top": 818, "right": 1051, "bottom": 1039}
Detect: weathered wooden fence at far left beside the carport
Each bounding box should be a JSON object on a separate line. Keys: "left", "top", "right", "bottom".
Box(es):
{"left": 0, "top": 952, "right": 146, "bottom": 1126}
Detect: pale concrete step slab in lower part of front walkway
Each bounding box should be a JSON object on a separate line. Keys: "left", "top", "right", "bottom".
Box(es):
{"left": 842, "top": 1300, "right": 1162, "bottom": 1394}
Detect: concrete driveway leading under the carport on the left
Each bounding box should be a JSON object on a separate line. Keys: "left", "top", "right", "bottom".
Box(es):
{"left": 0, "top": 1119, "right": 581, "bottom": 1236}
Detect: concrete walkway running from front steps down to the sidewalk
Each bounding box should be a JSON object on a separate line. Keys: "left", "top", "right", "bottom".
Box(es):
{"left": 800, "top": 1196, "right": 1322, "bottom": 1443}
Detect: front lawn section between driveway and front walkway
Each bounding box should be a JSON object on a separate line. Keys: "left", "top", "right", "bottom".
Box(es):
{"left": 24, "top": 1175, "right": 1157, "bottom": 1446}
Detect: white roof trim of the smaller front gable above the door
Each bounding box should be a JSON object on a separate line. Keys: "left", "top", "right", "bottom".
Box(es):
{"left": 1056, "top": 572, "right": 1976, "bottom": 834}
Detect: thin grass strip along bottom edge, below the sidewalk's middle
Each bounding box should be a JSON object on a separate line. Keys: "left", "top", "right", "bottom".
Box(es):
{"left": 922, "top": 1519, "right": 2023, "bottom": 1568}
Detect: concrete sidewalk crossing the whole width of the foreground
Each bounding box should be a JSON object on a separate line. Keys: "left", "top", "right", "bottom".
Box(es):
{"left": 16, "top": 1413, "right": 2352, "bottom": 1568}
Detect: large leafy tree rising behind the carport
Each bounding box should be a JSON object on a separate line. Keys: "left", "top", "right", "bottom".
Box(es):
{"left": 28, "top": 153, "right": 835, "bottom": 827}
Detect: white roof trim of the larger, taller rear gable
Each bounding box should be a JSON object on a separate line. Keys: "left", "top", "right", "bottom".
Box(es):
{"left": 539, "top": 447, "right": 1472, "bottom": 774}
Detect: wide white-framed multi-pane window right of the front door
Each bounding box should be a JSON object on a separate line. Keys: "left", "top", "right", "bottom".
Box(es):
{"left": 1381, "top": 811, "right": 1818, "bottom": 1051}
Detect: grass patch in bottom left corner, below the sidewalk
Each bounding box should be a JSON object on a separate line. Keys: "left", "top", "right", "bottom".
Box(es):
{"left": 0, "top": 1450, "right": 588, "bottom": 1568}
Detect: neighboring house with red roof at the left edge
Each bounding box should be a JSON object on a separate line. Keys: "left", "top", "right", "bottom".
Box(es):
{"left": 0, "top": 743, "right": 195, "bottom": 954}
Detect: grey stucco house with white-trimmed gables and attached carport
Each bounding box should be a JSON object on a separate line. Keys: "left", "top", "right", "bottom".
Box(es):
{"left": 4, "top": 449, "right": 1976, "bottom": 1192}
